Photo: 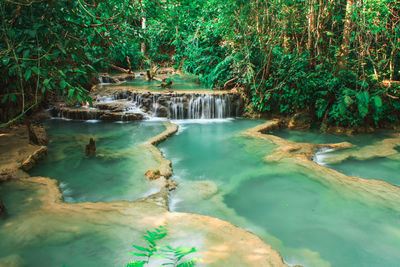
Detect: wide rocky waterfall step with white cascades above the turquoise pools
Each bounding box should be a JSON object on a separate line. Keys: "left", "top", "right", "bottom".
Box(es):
{"left": 51, "top": 91, "right": 243, "bottom": 121}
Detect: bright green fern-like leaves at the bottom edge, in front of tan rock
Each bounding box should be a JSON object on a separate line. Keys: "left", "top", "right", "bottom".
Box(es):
{"left": 125, "top": 226, "right": 198, "bottom": 267}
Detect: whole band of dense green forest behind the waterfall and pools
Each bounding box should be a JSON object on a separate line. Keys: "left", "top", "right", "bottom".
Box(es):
{"left": 0, "top": 0, "right": 400, "bottom": 127}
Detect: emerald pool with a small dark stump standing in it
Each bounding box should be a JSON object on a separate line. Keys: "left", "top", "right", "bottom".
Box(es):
{"left": 30, "top": 120, "right": 165, "bottom": 202}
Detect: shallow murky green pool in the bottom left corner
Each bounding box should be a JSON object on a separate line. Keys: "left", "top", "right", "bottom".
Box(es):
{"left": 0, "top": 182, "right": 147, "bottom": 267}
